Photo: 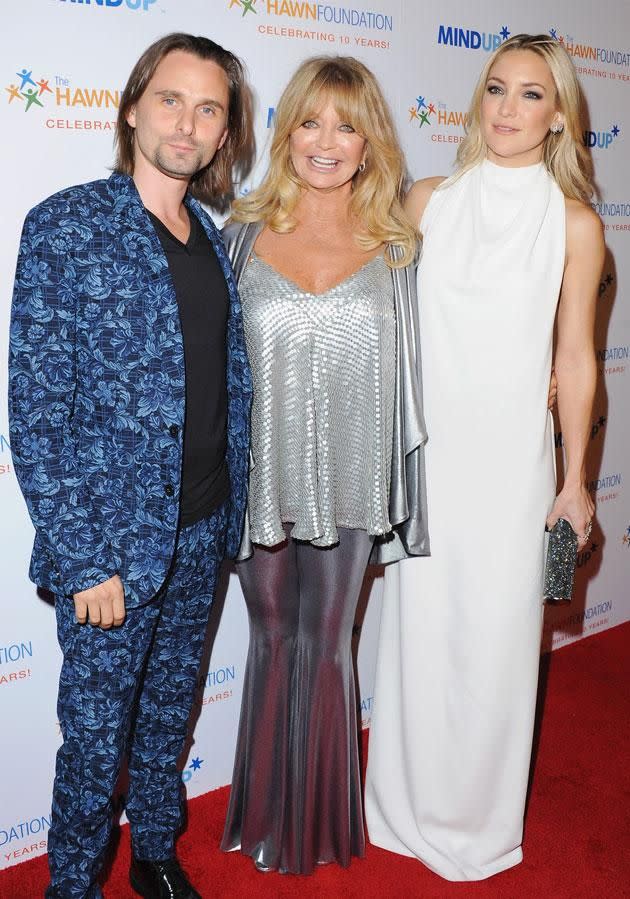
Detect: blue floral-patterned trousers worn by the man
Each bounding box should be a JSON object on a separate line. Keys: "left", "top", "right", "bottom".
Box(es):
{"left": 46, "top": 506, "right": 227, "bottom": 899}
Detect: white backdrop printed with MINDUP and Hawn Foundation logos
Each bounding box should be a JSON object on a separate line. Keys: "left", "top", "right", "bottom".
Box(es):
{"left": 0, "top": 0, "right": 630, "bottom": 868}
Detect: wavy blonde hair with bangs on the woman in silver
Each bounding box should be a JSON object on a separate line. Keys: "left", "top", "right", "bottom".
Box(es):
{"left": 232, "top": 56, "right": 417, "bottom": 268}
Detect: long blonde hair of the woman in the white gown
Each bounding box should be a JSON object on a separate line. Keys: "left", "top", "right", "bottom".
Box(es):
{"left": 448, "top": 34, "right": 593, "bottom": 203}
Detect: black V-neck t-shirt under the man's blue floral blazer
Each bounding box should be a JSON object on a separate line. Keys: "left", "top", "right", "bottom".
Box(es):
{"left": 147, "top": 210, "right": 230, "bottom": 527}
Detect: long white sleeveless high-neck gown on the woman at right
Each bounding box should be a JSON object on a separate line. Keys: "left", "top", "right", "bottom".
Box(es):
{"left": 366, "top": 161, "right": 565, "bottom": 880}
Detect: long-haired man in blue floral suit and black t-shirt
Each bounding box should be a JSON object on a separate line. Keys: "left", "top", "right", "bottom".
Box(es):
{"left": 10, "top": 34, "right": 251, "bottom": 899}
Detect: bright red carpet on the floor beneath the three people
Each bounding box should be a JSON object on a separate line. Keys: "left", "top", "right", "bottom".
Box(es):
{"left": 0, "top": 623, "right": 630, "bottom": 899}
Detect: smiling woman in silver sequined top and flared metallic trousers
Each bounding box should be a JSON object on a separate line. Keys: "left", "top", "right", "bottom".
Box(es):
{"left": 223, "top": 57, "right": 428, "bottom": 873}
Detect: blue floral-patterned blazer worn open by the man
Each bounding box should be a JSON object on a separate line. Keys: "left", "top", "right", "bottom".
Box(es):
{"left": 9, "top": 174, "right": 252, "bottom": 607}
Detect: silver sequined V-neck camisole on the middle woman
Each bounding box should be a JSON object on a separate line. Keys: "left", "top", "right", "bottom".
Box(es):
{"left": 239, "top": 253, "right": 396, "bottom": 546}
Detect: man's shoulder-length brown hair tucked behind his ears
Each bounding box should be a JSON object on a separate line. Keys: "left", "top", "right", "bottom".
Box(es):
{"left": 114, "top": 32, "right": 254, "bottom": 210}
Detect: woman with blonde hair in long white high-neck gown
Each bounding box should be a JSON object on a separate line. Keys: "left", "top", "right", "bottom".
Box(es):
{"left": 366, "top": 35, "right": 604, "bottom": 880}
